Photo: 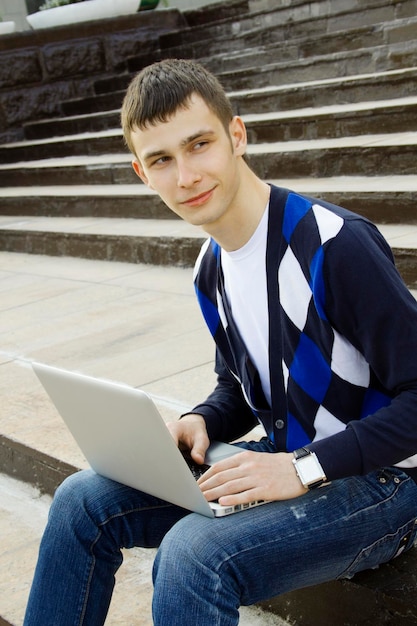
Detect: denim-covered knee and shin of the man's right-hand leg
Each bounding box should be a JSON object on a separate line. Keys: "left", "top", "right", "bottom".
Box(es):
{"left": 152, "top": 514, "right": 240, "bottom": 626}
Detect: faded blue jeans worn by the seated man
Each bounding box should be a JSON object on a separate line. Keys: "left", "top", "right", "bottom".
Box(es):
{"left": 24, "top": 444, "right": 417, "bottom": 626}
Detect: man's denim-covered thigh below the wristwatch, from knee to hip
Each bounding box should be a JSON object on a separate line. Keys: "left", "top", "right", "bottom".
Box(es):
{"left": 165, "top": 468, "right": 417, "bottom": 604}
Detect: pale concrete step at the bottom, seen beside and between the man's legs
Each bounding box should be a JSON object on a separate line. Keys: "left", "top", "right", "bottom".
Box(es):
{"left": 0, "top": 474, "right": 287, "bottom": 626}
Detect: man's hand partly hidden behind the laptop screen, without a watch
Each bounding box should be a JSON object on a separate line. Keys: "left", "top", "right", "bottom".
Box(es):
{"left": 167, "top": 413, "right": 210, "bottom": 465}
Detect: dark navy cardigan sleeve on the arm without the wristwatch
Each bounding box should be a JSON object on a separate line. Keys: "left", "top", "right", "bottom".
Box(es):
{"left": 191, "top": 350, "right": 258, "bottom": 442}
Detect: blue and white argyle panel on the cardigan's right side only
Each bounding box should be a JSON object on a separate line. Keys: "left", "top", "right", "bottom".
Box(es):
{"left": 278, "top": 194, "right": 390, "bottom": 450}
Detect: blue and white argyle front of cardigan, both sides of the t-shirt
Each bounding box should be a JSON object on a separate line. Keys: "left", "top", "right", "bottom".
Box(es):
{"left": 194, "top": 192, "right": 391, "bottom": 451}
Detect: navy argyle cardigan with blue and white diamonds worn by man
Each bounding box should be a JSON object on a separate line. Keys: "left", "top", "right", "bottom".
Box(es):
{"left": 193, "top": 186, "right": 417, "bottom": 480}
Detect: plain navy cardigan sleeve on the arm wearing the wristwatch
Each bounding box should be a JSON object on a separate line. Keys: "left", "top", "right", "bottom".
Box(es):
{"left": 309, "top": 218, "right": 417, "bottom": 479}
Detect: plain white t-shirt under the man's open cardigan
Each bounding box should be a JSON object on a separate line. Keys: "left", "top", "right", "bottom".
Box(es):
{"left": 221, "top": 203, "right": 271, "bottom": 404}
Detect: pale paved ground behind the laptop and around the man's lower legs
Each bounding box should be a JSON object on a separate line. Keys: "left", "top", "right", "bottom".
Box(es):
{"left": 0, "top": 252, "right": 283, "bottom": 626}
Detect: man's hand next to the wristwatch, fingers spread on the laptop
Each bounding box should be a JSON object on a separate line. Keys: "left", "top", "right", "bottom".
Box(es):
{"left": 198, "top": 450, "right": 307, "bottom": 506}
